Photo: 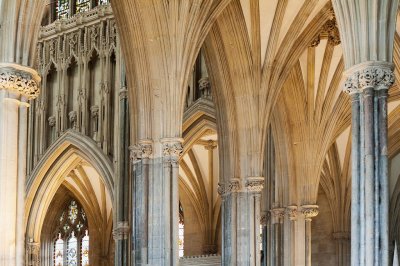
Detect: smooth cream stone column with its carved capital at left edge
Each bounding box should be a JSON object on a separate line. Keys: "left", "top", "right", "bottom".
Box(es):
{"left": 0, "top": 63, "right": 40, "bottom": 266}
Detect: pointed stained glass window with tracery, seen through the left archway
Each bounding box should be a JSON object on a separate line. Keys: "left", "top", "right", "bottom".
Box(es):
{"left": 53, "top": 200, "right": 89, "bottom": 266}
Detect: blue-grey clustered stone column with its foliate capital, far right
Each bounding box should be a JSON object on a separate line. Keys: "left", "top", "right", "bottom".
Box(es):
{"left": 345, "top": 62, "right": 394, "bottom": 265}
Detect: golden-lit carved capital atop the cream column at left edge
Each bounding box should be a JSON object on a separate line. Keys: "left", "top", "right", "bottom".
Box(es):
{"left": 0, "top": 63, "right": 40, "bottom": 99}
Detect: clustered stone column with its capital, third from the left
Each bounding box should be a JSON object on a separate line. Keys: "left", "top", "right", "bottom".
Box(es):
{"left": 219, "top": 177, "right": 264, "bottom": 266}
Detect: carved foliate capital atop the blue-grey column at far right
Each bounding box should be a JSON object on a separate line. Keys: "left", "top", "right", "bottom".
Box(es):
{"left": 344, "top": 62, "right": 395, "bottom": 94}
